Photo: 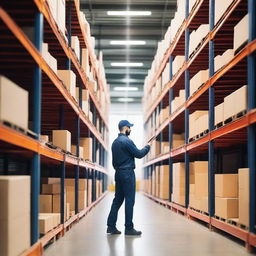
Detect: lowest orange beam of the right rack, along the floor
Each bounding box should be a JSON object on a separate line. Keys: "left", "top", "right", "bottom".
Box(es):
{"left": 143, "top": 192, "right": 256, "bottom": 251}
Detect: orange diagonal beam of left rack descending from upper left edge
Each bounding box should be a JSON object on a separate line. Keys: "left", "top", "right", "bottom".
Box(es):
{"left": 0, "top": 9, "right": 107, "bottom": 149}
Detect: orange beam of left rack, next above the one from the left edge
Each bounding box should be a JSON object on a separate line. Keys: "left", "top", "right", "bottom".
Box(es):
{"left": 35, "top": 0, "right": 108, "bottom": 128}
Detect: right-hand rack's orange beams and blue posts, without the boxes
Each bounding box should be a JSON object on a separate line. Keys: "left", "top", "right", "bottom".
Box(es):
{"left": 144, "top": 0, "right": 256, "bottom": 250}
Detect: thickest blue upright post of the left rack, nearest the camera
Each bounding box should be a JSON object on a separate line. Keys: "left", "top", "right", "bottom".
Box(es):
{"left": 31, "top": 12, "right": 43, "bottom": 245}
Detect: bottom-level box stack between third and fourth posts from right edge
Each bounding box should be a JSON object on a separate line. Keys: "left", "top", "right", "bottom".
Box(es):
{"left": 172, "top": 163, "right": 185, "bottom": 206}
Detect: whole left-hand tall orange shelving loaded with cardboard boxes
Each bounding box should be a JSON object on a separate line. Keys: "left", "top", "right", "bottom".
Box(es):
{"left": 0, "top": 0, "right": 110, "bottom": 255}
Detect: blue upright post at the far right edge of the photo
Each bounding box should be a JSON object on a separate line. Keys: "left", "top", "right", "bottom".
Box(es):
{"left": 247, "top": 0, "right": 256, "bottom": 233}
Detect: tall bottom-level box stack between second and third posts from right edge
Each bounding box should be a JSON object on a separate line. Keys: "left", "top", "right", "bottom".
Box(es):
{"left": 189, "top": 161, "right": 208, "bottom": 212}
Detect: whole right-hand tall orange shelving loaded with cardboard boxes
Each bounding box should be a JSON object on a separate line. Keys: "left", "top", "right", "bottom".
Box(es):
{"left": 144, "top": 0, "right": 256, "bottom": 252}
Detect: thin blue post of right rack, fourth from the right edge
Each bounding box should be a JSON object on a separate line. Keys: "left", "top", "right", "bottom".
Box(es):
{"left": 169, "top": 56, "right": 173, "bottom": 202}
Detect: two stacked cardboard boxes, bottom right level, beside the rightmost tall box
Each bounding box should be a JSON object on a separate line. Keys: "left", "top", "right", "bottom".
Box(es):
{"left": 215, "top": 174, "right": 238, "bottom": 219}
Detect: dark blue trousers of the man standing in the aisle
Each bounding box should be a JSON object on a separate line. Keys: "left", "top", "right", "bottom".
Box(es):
{"left": 107, "top": 169, "right": 136, "bottom": 229}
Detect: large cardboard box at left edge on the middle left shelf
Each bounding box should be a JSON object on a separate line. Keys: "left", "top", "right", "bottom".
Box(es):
{"left": 0, "top": 75, "right": 29, "bottom": 129}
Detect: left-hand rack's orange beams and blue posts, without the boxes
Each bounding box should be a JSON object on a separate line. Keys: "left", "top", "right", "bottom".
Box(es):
{"left": 0, "top": 0, "right": 110, "bottom": 255}
